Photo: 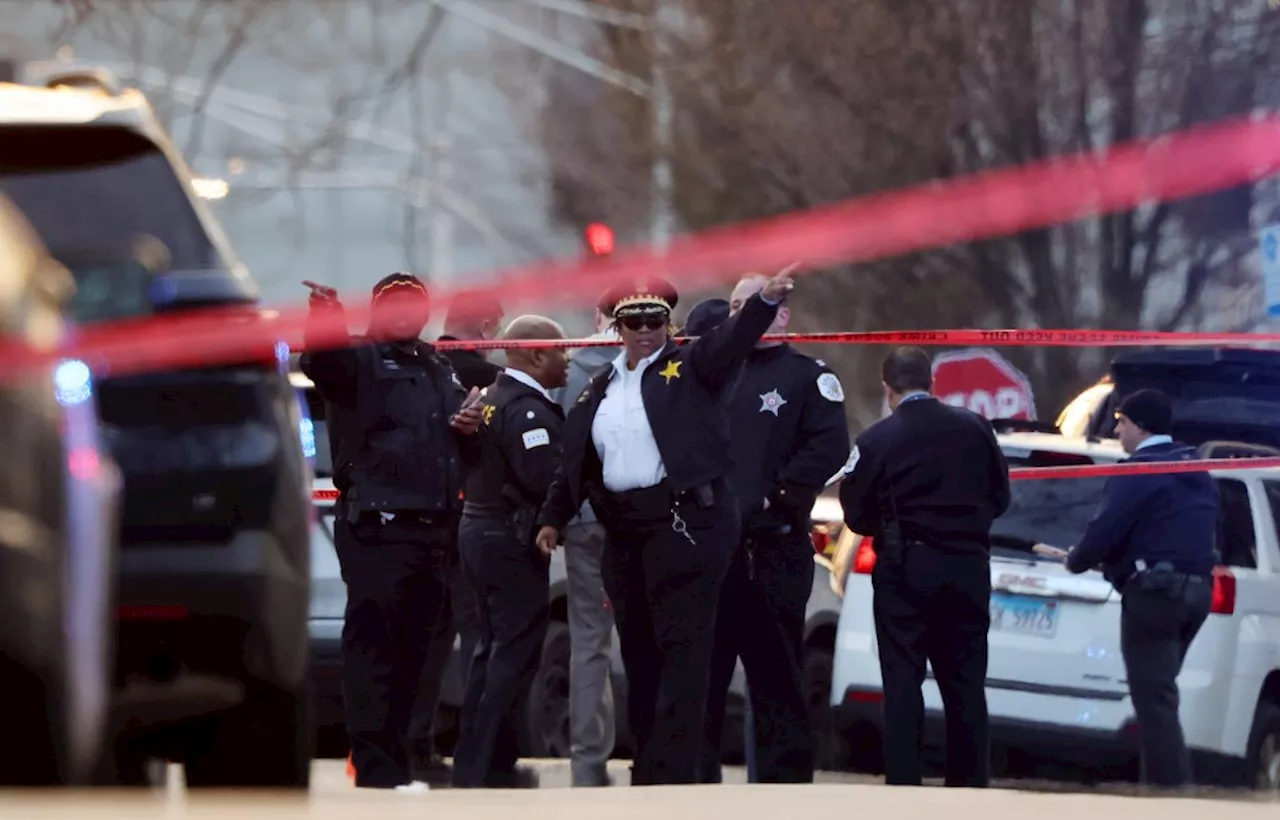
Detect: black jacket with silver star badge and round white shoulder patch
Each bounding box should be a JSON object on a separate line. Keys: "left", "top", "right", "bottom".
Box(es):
{"left": 728, "top": 344, "right": 849, "bottom": 528}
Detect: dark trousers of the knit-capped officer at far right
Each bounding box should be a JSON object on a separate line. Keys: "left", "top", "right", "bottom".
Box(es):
{"left": 1120, "top": 576, "right": 1212, "bottom": 787}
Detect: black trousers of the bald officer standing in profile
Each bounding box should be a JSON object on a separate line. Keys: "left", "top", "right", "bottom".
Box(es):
{"left": 453, "top": 516, "right": 550, "bottom": 788}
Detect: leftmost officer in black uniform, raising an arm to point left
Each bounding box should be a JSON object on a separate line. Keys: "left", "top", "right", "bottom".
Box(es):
{"left": 301, "top": 274, "right": 483, "bottom": 788}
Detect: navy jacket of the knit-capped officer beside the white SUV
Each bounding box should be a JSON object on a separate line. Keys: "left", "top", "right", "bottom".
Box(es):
{"left": 1066, "top": 443, "right": 1219, "bottom": 588}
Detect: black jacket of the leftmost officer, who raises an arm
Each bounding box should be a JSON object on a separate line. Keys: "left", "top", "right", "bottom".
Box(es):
{"left": 300, "top": 296, "right": 470, "bottom": 514}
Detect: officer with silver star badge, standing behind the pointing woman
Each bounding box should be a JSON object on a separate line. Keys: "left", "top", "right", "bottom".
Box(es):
{"left": 703, "top": 275, "right": 849, "bottom": 783}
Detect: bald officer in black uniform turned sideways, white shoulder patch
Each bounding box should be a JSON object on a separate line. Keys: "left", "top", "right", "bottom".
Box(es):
{"left": 453, "top": 316, "right": 568, "bottom": 788}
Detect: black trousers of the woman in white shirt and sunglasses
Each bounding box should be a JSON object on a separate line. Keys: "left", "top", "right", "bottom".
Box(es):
{"left": 596, "top": 484, "right": 740, "bottom": 785}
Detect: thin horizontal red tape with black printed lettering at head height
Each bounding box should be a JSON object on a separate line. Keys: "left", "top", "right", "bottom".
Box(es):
{"left": 424, "top": 330, "right": 1280, "bottom": 351}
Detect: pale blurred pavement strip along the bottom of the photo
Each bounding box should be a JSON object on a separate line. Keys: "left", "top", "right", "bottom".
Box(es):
{"left": 0, "top": 761, "right": 1276, "bottom": 820}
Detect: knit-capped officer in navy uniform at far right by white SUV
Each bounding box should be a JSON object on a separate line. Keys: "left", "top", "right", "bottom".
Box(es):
{"left": 1044, "top": 390, "right": 1220, "bottom": 788}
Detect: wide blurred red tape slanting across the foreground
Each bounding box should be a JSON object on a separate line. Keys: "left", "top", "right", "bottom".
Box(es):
{"left": 0, "top": 116, "right": 1280, "bottom": 379}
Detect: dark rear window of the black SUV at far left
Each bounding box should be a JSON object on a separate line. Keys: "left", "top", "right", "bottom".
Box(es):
{"left": 0, "top": 125, "right": 225, "bottom": 314}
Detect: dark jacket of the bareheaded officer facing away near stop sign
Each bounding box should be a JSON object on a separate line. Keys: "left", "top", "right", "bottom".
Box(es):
{"left": 840, "top": 398, "right": 1009, "bottom": 554}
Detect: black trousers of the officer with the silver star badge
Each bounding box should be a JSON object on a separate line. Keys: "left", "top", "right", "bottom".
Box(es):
{"left": 701, "top": 524, "right": 814, "bottom": 783}
